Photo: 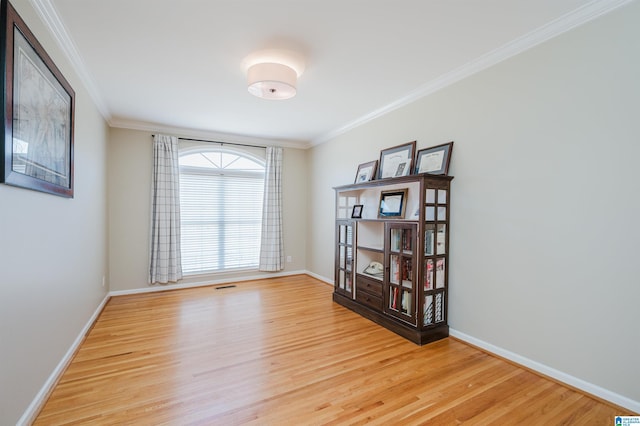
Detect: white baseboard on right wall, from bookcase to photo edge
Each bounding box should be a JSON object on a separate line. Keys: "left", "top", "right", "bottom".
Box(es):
{"left": 449, "top": 328, "right": 640, "bottom": 413}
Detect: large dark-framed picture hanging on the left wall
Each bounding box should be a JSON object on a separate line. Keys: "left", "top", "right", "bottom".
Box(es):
{"left": 0, "top": 0, "right": 75, "bottom": 198}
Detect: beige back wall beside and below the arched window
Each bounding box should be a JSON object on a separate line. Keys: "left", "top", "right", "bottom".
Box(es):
{"left": 109, "top": 128, "right": 307, "bottom": 291}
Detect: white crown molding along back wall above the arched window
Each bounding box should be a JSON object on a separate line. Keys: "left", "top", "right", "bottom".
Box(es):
{"left": 109, "top": 119, "right": 311, "bottom": 149}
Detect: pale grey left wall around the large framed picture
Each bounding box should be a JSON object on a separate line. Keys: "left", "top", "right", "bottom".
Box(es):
{"left": 0, "top": 0, "right": 107, "bottom": 425}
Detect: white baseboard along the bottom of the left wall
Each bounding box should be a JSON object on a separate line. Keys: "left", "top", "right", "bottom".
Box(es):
{"left": 16, "top": 294, "right": 111, "bottom": 426}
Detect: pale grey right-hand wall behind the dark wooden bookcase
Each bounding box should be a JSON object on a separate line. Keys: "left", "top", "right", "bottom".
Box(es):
{"left": 307, "top": 2, "right": 640, "bottom": 407}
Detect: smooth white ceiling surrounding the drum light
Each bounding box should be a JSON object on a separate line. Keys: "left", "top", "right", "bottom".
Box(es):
{"left": 31, "top": 0, "right": 624, "bottom": 147}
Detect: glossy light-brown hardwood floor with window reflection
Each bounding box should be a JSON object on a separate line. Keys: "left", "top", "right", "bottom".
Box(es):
{"left": 35, "top": 275, "right": 632, "bottom": 425}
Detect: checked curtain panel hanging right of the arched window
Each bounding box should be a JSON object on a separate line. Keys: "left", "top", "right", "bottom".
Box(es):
{"left": 259, "top": 147, "right": 284, "bottom": 272}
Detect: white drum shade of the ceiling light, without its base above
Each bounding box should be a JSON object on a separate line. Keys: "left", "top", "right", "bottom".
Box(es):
{"left": 247, "top": 62, "right": 298, "bottom": 99}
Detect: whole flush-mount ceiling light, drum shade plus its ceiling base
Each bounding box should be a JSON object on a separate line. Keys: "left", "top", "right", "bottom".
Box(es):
{"left": 242, "top": 49, "right": 304, "bottom": 99}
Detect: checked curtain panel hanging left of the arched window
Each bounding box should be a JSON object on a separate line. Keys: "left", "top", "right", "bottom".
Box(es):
{"left": 149, "top": 135, "right": 182, "bottom": 284}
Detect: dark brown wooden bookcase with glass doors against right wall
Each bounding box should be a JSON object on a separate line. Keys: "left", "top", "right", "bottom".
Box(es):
{"left": 333, "top": 174, "right": 453, "bottom": 345}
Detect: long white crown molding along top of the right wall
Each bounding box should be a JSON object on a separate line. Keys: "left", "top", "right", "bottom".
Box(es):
{"left": 311, "top": 0, "right": 634, "bottom": 146}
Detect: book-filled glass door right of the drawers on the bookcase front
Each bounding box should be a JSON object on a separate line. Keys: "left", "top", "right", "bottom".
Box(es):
{"left": 384, "top": 223, "right": 417, "bottom": 324}
